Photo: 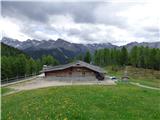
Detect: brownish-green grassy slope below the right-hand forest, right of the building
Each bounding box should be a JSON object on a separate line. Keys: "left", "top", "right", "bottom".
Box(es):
{"left": 106, "top": 66, "right": 160, "bottom": 88}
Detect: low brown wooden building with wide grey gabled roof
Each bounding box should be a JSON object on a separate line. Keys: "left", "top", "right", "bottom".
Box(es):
{"left": 43, "top": 61, "right": 105, "bottom": 80}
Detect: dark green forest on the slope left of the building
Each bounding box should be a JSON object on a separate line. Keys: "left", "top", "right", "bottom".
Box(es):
{"left": 1, "top": 43, "right": 59, "bottom": 80}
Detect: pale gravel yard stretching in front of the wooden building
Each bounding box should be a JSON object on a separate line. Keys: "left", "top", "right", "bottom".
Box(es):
{"left": 8, "top": 77, "right": 115, "bottom": 90}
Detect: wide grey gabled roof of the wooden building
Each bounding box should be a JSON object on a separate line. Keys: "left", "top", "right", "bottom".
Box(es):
{"left": 42, "top": 61, "right": 105, "bottom": 73}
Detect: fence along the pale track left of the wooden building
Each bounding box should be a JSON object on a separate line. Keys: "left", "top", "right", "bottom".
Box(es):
{"left": 1, "top": 73, "right": 39, "bottom": 85}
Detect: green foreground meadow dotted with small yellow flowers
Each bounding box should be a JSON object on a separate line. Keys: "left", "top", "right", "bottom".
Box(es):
{"left": 2, "top": 84, "right": 160, "bottom": 120}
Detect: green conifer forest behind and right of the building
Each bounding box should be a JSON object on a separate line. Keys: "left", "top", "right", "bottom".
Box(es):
{"left": 75, "top": 46, "right": 160, "bottom": 70}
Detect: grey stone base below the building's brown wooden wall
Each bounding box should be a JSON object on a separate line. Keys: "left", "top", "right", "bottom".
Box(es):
{"left": 44, "top": 76, "right": 98, "bottom": 82}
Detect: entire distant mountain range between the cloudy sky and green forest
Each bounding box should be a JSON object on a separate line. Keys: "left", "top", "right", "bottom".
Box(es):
{"left": 1, "top": 37, "right": 160, "bottom": 63}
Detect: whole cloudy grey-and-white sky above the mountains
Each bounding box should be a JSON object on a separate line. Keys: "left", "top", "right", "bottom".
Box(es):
{"left": 0, "top": 0, "right": 160, "bottom": 45}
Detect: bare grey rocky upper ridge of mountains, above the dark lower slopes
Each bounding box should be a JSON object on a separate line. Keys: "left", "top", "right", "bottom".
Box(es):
{"left": 1, "top": 37, "right": 160, "bottom": 53}
